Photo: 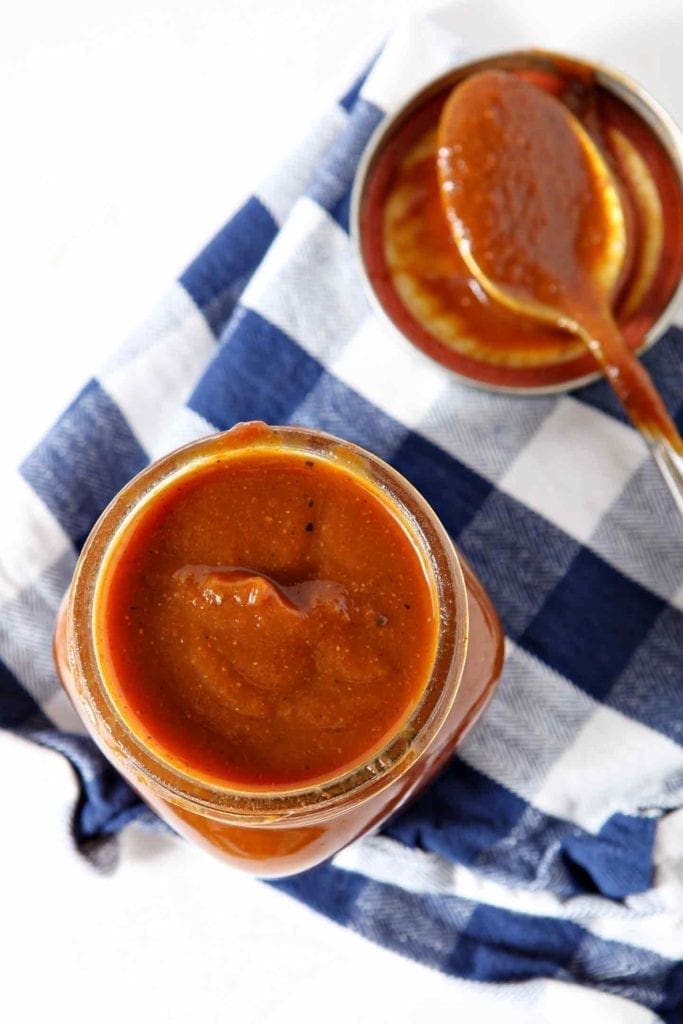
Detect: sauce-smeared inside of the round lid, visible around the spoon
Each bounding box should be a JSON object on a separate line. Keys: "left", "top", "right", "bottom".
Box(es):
{"left": 359, "top": 65, "right": 683, "bottom": 388}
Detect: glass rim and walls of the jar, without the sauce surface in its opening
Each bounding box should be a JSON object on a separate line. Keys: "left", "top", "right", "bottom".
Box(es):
{"left": 54, "top": 427, "right": 503, "bottom": 878}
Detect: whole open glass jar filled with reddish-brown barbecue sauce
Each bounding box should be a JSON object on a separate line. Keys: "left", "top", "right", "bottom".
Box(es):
{"left": 55, "top": 423, "right": 503, "bottom": 877}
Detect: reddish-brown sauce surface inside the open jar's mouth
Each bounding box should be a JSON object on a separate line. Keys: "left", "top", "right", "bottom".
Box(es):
{"left": 95, "top": 428, "right": 438, "bottom": 788}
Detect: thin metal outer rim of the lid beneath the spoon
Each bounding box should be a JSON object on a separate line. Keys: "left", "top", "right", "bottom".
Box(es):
{"left": 350, "top": 50, "right": 683, "bottom": 395}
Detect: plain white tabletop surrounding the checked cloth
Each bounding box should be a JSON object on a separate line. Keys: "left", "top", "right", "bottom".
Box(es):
{"left": 0, "top": 0, "right": 683, "bottom": 1024}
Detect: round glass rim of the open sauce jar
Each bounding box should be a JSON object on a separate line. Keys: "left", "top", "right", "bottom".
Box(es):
{"left": 67, "top": 425, "right": 469, "bottom": 824}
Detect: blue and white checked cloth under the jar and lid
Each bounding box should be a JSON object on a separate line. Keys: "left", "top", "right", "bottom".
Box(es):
{"left": 0, "top": 20, "right": 683, "bottom": 1024}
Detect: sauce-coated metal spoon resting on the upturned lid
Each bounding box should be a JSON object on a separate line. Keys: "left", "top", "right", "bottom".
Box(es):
{"left": 438, "top": 71, "right": 683, "bottom": 514}
